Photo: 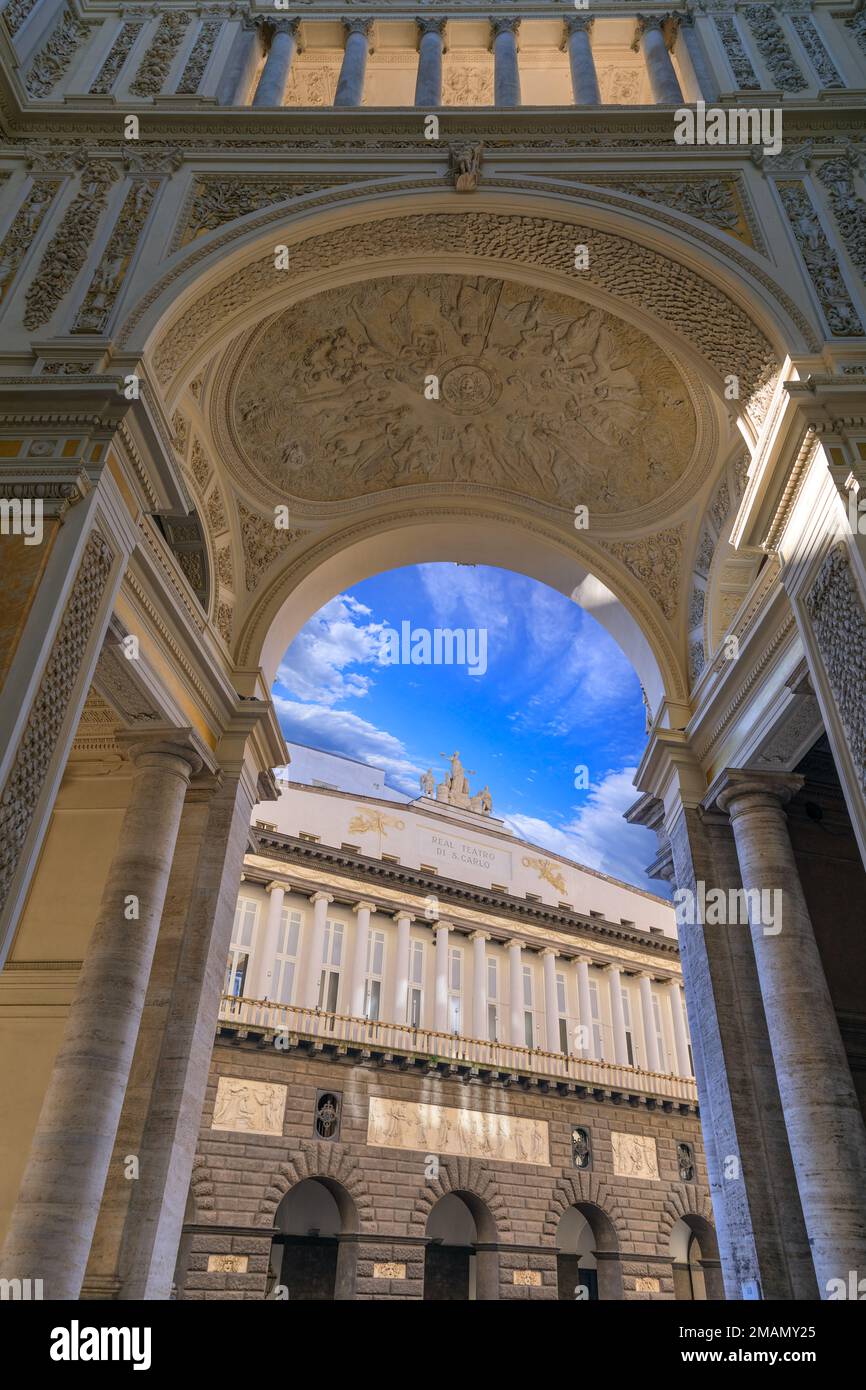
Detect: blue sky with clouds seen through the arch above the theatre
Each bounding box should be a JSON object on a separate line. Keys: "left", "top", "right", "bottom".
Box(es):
{"left": 274, "top": 564, "right": 663, "bottom": 892}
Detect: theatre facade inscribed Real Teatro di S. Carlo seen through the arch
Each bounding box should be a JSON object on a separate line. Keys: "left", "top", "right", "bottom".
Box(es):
{"left": 177, "top": 755, "right": 723, "bottom": 1300}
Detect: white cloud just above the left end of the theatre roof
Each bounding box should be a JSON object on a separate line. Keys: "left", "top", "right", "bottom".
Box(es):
{"left": 274, "top": 695, "right": 423, "bottom": 796}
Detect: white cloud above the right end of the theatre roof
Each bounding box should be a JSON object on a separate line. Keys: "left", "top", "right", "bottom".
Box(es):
{"left": 505, "top": 767, "right": 664, "bottom": 897}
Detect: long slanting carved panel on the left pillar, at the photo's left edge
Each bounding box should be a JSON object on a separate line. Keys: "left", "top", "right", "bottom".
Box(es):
{"left": 0, "top": 531, "right": 113, "bottom": 909}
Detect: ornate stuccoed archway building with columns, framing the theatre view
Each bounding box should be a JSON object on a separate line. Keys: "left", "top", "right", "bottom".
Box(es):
{"left": 0, "top": 0, "right": 866, "bottom": 1298}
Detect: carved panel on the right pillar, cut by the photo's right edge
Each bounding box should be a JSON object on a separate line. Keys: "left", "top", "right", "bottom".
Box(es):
{"left": 806, "top": 542, "right": 866, "bottom": 792}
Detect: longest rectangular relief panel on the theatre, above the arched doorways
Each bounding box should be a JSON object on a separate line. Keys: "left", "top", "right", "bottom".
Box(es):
{"left": 367, "top": 1095, "right": 550, "bottom": 1168}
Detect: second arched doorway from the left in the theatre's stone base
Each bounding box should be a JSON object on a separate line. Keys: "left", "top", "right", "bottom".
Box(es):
{"left": 424, "top": 1193, "right": 499, "bottom": 1302}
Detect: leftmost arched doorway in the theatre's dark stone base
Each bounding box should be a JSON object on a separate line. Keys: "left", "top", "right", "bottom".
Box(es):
{"left": 267, "top": 1177, "right": 357, "bottom": 1302}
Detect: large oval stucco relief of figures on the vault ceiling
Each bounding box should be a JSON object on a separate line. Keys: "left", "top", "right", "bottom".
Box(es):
{"left": 231, "top": 275, "right": 696, "bottom": 513}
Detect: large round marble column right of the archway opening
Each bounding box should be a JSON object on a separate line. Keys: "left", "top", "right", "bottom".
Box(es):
{"left": 716, "top": 769, "right": 866, "bottom": 1298}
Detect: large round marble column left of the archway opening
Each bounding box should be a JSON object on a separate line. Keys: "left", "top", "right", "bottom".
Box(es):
{"left": 0, "top": 727, "right": 202, "bottom": 1300}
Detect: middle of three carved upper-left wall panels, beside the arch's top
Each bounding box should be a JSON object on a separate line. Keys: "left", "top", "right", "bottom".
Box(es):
{"left": 24, "top": 160, "right": 117, "bottom": 329}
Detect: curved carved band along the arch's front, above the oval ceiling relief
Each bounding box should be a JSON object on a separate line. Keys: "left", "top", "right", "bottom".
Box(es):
{"left": 154, "top": 211, "right": 777, "bottom": 434}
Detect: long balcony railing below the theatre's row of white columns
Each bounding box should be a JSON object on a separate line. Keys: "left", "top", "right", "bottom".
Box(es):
{"left": 220, "top": 994, "right": 698, "bottom": 1105}
